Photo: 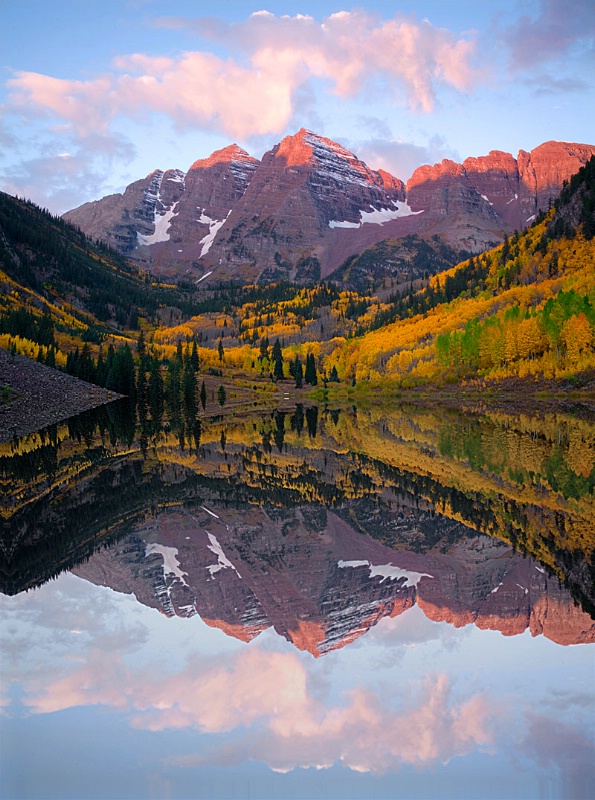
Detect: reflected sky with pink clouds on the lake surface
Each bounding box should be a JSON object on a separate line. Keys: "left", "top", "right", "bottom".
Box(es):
{"left": 0, "top": 573, "right": 594, "bottom": 800}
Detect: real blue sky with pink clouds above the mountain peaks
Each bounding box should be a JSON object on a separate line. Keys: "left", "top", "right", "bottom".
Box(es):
{"left": 0, "top": 0, "right": 595, "bottom": 213}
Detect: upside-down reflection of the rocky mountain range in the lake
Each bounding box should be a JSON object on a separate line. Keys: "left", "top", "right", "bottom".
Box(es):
{"left": 74, "top": 504, "right": 595, "bottom": 656}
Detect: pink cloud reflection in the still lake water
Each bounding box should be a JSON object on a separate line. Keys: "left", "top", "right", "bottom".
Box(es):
{"left": 23, "top": 647, "right": 497, "bottom": 772}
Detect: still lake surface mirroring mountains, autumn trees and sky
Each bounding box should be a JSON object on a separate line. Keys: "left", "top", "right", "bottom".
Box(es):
{"left": 0, "top": 404, "right": 595, "bottom": 798}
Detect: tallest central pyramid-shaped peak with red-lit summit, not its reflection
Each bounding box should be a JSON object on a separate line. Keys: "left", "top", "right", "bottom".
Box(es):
{"left": 200, "top": 129, "right": 406, "bottom": 281}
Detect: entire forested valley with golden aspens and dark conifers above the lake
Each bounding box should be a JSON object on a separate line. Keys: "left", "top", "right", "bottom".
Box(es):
{"left": 0, "top": 159, "right": 595, "bottom": 404}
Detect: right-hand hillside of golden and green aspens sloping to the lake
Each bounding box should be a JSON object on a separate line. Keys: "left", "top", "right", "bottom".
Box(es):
{"left": 324, "top": 160, "right": 595, "bottom": 386}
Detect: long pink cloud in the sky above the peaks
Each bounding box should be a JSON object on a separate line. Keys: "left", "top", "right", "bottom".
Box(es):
{"left": 8, "top": 11, "right": 479, "bottom": 139}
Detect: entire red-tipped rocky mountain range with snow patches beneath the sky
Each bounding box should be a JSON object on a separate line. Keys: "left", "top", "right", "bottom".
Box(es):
{"left": 64, "top": 134, "right": 595, "bottom": 283}
